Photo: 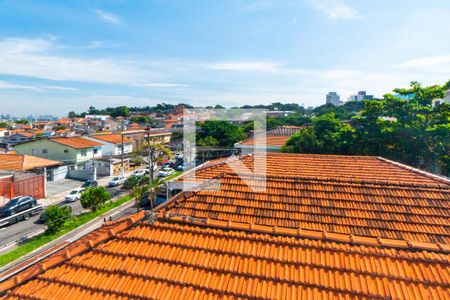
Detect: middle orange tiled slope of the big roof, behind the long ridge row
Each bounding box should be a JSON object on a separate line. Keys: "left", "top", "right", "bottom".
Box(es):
{"left": 163, "top": 174, "right": 450, "bottom": 244}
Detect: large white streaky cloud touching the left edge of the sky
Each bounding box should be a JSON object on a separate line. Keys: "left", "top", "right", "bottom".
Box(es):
{"left": 0, "top": 37, "right": 157, "bottom": 84}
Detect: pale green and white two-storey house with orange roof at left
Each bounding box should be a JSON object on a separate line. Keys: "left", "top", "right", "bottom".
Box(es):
{"left": 15, "top": 137, "right": 103, "bottom": 165}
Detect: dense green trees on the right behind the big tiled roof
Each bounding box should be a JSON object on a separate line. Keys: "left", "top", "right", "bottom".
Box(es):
{"left": 282, "top": 81, "right": 450, "bottom": 175}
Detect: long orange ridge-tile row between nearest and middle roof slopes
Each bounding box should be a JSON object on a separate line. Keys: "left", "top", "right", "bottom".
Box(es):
{"left": 162, "top": 213, "right": 450, "bottom": 253}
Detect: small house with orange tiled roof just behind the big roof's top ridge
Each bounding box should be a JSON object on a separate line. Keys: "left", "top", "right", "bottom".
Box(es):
{"left": 234, "top": 126, "right": 303, "bottom": 154}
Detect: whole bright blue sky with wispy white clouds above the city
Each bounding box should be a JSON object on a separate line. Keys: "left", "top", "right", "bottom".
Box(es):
{"left": 0, "top": 0, "right": 450, "bottom": 116}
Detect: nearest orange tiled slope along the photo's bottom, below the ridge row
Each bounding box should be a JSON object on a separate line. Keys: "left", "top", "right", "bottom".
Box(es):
{"left": 0, "top": 212, "right": 450, "bottom": 299}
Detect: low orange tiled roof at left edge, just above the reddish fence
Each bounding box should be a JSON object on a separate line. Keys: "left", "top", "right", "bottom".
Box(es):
{"left": 0, "top": 154, "right": 62, "bottom": 171}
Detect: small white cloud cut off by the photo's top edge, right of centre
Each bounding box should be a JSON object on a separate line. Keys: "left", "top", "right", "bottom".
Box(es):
{"left": 307, "top": 0, "right": 362, "bottom": 20}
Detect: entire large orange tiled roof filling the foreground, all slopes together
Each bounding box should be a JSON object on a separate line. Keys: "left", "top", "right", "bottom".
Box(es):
{"left": 0, "top": 153, "right": 450, "bottom": 299}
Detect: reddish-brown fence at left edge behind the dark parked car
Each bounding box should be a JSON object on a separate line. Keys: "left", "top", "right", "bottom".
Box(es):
{"left": 0, "top": 175, "right": 45, "bottom": 206}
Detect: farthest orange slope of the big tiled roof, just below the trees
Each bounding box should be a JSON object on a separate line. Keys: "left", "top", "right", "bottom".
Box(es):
{"left": 188, "top": 152, "right": 449, "bottom": 186}
